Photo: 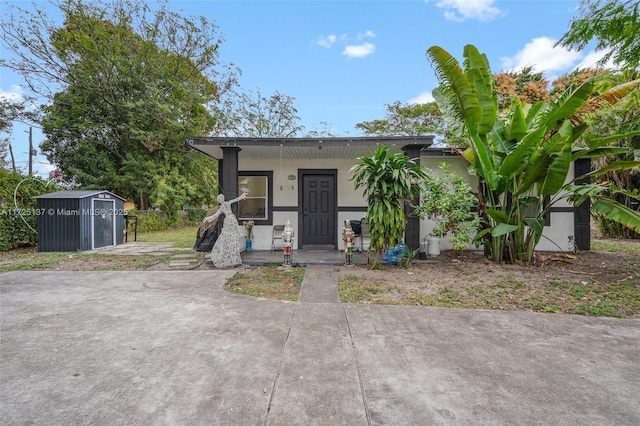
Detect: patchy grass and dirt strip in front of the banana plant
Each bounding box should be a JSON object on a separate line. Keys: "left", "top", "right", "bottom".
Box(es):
{"left": 338, "top": 242, "right": 640, "bottom": 318}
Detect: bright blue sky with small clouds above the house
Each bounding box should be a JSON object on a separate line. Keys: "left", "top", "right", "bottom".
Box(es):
{"left": 0, "top": 0, "right": 602, "bottom": 176}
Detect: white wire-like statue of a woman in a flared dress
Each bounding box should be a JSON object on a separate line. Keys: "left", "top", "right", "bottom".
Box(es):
{"left": 203, "top": 192, "right": 247, "bottom": 268}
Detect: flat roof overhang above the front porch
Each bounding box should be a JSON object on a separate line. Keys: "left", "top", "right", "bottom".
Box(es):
{"left": 185, "top": 136, "right": 433, "bottom": 160}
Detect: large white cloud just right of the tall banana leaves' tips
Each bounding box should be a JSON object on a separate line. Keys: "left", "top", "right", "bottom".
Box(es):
{"left": 500, "top": 37, "right": 582, "bottom": 72}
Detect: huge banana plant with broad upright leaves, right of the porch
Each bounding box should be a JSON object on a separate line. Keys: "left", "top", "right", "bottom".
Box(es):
{"left": 427, "top": 45, "right": 640, "bottom": 262}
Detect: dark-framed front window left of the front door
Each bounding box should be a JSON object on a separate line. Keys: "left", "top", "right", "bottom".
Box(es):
{"left": 238, "top": 172, "right": 273, "bottom": 225}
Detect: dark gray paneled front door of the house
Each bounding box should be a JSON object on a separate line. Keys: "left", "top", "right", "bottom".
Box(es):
{"left": 301, "top": 170, "right": 337, "bottom": 247}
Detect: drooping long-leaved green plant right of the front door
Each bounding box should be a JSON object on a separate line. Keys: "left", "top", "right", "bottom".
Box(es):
{"left": 349, "top": 145, "right": 426, "bottom": 268}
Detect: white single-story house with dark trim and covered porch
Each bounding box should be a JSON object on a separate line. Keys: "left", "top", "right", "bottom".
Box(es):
{"left": 185, "top": 136, "right": 590, "bottom": 251}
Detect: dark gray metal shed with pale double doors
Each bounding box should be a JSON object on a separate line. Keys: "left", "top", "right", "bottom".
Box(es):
{"left": 35, "top": 190, "right": 125, "bottom": 252}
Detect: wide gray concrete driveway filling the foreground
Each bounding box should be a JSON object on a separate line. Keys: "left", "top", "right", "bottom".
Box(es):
{"left": 0, "top": 267, "right": 640, "bottom": 425}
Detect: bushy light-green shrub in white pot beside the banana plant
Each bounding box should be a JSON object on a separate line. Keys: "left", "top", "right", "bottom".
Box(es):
{"left": 415, "top": 163, "right": 480, "bottom": 256}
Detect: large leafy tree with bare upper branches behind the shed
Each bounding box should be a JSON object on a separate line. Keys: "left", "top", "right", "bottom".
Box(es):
{"left": 2, "top": 0, "right": 235, "bottom": 209}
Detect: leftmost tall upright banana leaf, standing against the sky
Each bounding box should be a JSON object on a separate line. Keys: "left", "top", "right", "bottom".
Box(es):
{"left": 427, "top": 46, "right": 482, "bottom": 123}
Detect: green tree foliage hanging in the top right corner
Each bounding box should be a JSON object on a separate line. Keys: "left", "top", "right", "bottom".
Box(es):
{"left": 556, "top": 0, "right": 640, "bottom": 74}
